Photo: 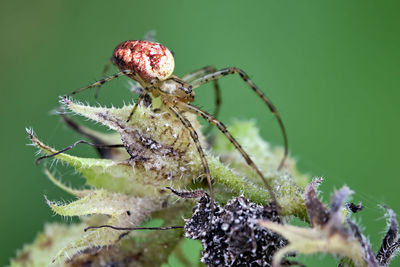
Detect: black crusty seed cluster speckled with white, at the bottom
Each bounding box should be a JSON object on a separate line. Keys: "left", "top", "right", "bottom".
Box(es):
{"left": 185, "top": 195, "right": 287, "bottom": 266}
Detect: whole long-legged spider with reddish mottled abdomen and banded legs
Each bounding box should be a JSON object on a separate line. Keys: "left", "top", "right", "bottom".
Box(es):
{"left": 45, "top": 40, "right": 288, "bottom": 209}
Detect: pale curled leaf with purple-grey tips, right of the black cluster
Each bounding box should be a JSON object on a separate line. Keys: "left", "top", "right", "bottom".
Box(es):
{"left": 258, "top": 180, "right": 390, "bottom": 267}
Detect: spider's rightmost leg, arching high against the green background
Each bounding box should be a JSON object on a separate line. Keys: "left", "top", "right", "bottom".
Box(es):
{"left": 192, "top": 67, "right": 289, "bottom": 170}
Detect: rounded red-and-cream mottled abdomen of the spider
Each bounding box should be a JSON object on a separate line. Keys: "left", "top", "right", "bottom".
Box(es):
{"left": 112, "top": 40, "right": 175, "bottom": 82}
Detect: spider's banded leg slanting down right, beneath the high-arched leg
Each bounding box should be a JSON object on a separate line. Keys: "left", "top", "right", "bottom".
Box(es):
{"left": 179, "top": 103, "right": 278, "bottom": 204}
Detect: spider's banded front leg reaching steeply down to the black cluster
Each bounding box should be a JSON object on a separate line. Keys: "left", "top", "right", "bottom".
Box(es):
{"left": 169, "top": 107, "right": 214, "bottom": 214}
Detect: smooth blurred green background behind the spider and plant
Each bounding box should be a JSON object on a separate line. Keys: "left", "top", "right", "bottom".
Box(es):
{"left": 0, "top": 0, "right": 400, "bottom": 266}
